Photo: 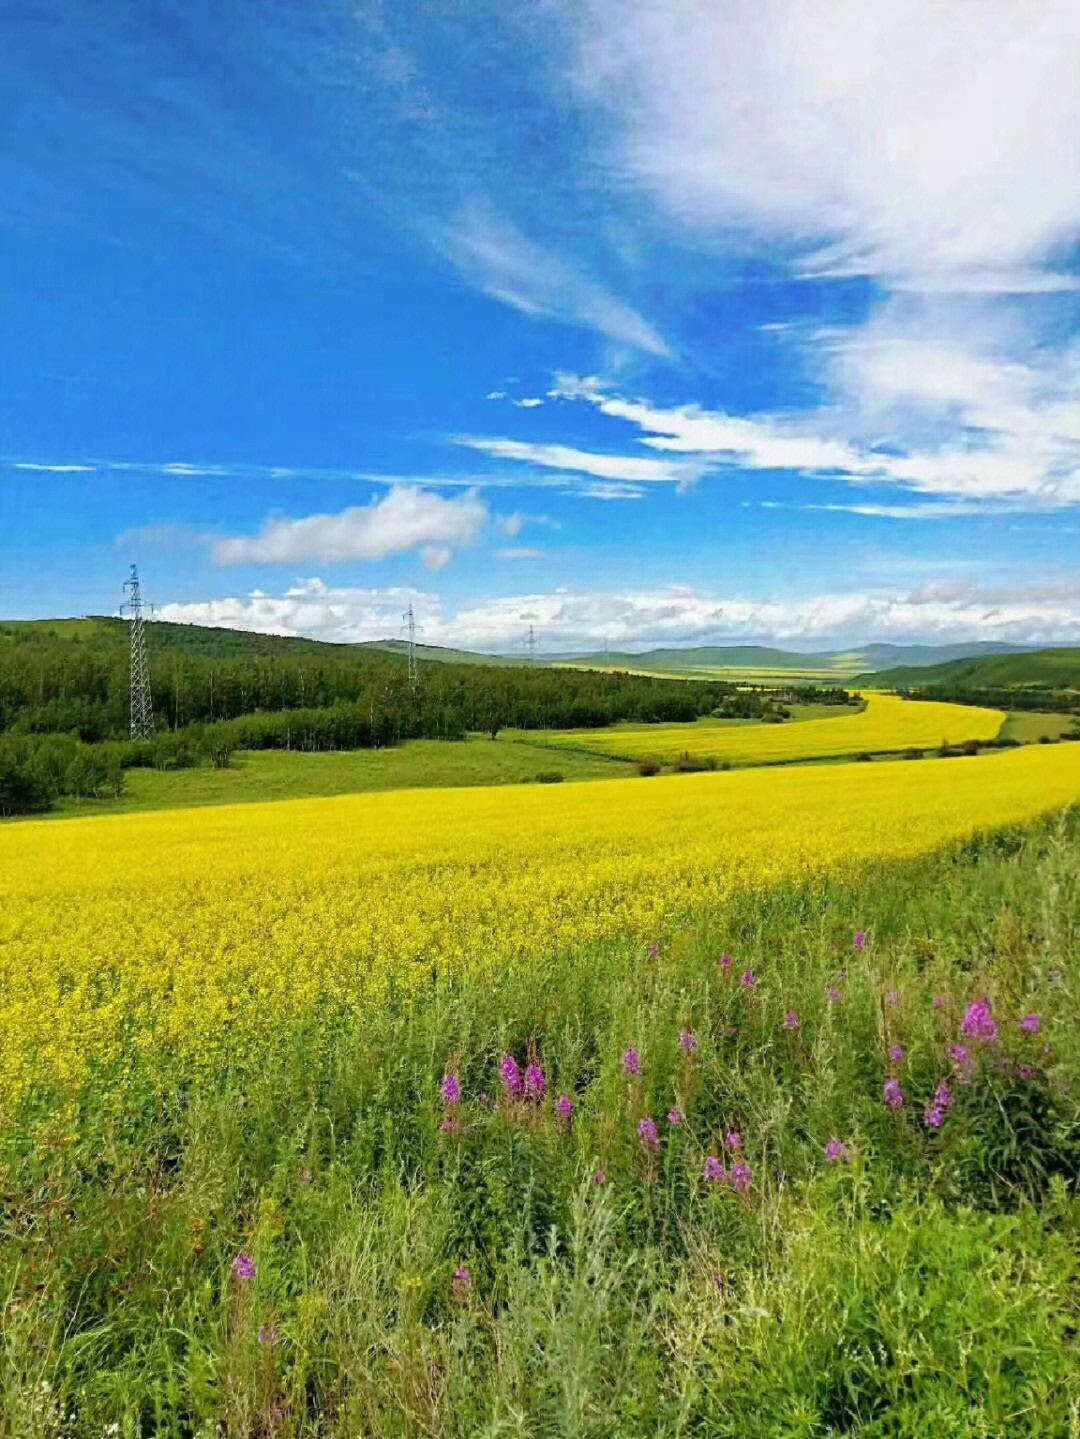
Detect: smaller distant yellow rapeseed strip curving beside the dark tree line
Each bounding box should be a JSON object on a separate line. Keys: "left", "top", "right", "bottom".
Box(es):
{"left": 545, "top": 694, "right": 1005, "bottom": 764}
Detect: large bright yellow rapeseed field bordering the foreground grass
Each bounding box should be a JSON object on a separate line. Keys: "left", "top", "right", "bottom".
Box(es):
{"left": 0, "top": 742, "right": 1080, "bottom": 1102}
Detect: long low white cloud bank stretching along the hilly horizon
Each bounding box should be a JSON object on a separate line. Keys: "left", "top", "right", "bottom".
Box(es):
{"left": 158, "top": 578, "right": 1080, "bottom": 650}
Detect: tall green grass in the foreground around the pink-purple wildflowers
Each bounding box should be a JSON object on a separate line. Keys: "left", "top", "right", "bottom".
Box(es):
{"left": 0, "top": 816, "right": 1080, "bottom": 1439}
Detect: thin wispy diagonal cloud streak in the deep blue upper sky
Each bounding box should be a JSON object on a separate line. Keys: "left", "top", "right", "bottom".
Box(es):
{"left": 430, "top": 201, "right": 669, "bottom": 356}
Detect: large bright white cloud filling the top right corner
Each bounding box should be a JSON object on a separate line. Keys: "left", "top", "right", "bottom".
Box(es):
{"left": 574, "top": 0, "right": 1080, "bottom": 289}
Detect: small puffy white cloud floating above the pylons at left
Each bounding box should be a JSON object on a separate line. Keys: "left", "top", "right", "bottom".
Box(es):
{"left": 214, "top": 485, "right": 488, "bottom": 568}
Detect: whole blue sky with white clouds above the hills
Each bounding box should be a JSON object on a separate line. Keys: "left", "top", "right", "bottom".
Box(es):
{"left": 0, "top": 0, "right": 1080, "bottom": 650}
